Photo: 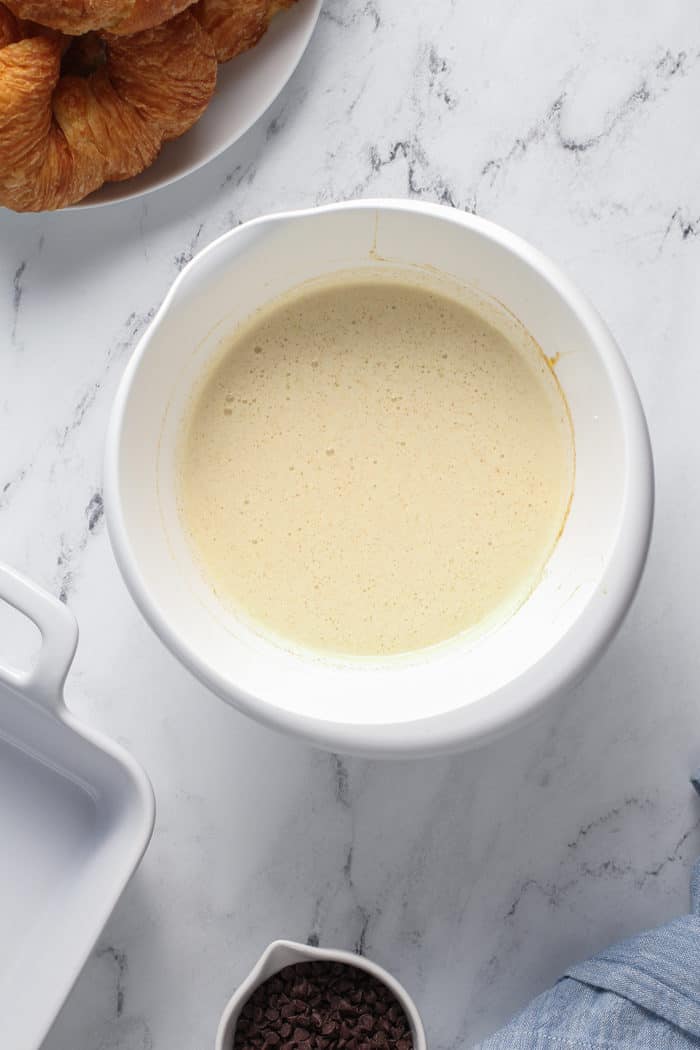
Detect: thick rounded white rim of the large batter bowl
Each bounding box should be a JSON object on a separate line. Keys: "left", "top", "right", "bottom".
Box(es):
{"left": 104, "top": 198, "right": 654, "bottom": 757}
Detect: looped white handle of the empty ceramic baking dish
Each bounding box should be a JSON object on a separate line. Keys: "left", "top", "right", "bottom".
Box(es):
{"left": 0, "top": 565, "right": 78, "bottom": 712}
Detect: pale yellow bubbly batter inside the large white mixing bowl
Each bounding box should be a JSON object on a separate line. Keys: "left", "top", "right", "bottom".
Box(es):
{"left": 178, "top": 271, "right": 573, "bottom": 654}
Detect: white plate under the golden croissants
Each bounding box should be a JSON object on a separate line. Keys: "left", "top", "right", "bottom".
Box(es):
{"left": 79, "top": 0, "right": 323, "bottom": 208}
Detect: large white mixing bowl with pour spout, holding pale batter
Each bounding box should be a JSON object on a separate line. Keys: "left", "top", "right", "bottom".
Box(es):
{"left": 105, "top": 201, "right": 653, "bottom": 757}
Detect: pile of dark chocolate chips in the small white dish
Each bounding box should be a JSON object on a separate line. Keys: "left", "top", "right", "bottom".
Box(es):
{"left": 233, "top": 962, "right": 413, "bottom": 1050}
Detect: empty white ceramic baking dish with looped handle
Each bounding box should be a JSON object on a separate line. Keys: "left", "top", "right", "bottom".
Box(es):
{"left": 0, "top": 566, "right": 155, "bottom": 1050}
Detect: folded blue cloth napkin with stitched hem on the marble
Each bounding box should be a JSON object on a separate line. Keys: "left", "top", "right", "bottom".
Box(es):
{"left": 474, "top": 781, "right": 700, "bottom": 1050}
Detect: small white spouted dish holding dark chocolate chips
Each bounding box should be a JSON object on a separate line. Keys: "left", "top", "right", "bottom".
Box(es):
{"left": 214, "top": 941, "right": 426, "bottom": 1050}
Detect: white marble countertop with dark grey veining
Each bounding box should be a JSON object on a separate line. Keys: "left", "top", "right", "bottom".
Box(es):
{"left": 0, "top": 0, "right": 700, "bottom": 1050}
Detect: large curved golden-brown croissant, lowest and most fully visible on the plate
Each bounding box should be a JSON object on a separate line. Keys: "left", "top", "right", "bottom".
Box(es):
{"left": 0, "top": 3, "right": 216, "bottom": 211}
